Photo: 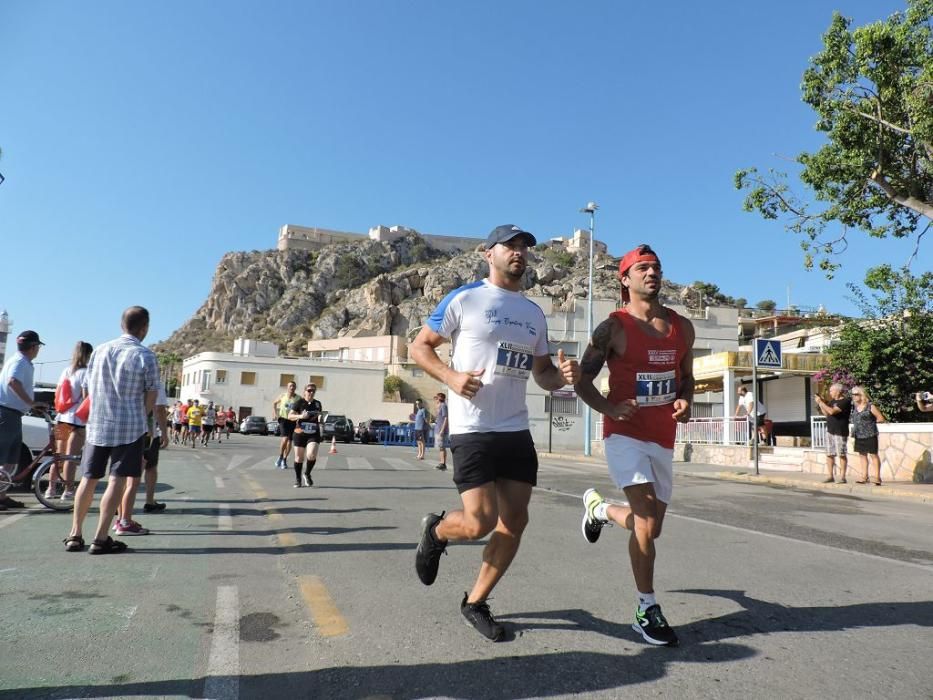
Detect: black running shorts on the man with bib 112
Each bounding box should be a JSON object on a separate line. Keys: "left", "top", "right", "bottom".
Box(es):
{"left": 450, "top": 430, "right": 538, "bottom": 493}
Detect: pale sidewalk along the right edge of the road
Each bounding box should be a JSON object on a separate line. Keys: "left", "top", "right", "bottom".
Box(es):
{"left": 538, "top": 452, "right": 933, "bottom": 504}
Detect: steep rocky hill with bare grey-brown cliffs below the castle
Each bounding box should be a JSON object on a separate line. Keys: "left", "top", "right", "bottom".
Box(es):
{"left": 154, "top": 233, "right": 695, "bottom": 357}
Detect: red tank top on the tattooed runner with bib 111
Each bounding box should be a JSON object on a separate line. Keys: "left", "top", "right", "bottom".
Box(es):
{"left": 603, "top": 307, "right": 688, "bottom": 449}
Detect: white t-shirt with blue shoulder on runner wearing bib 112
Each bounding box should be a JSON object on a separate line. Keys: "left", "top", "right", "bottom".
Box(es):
{"left": 427, "top": 280, "right": 548, "bottom": 435}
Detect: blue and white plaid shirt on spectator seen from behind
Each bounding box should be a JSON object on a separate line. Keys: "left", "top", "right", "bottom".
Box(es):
{"left": 84, "top": 334, "right": 159, "bottom": 447}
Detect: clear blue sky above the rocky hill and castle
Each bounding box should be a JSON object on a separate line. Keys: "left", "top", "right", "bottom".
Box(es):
{"left": 0, "top": 0, "right": 916, "bottom": 381}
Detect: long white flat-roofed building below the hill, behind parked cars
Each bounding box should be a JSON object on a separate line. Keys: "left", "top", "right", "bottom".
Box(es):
{"left": 180, "top": 339, "right": 411, "bottom": 422}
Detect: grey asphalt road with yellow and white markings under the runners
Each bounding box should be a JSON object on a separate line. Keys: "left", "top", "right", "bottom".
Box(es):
{"left": 0, "top": 436, "right": 933, "bottom": 700}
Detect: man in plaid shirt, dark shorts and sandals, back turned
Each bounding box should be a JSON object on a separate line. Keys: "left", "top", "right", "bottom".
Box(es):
{"left": 65, "top": 306, "right": 161, "bottom": 554}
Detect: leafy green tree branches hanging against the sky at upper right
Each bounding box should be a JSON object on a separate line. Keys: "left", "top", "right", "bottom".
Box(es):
{"left": 735, "top": 0, "right": 933, "bottom": 277}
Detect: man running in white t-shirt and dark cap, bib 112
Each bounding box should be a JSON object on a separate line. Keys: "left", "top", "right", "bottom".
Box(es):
{"left": 411, "top": 224, "right": 580, "bottom": 641}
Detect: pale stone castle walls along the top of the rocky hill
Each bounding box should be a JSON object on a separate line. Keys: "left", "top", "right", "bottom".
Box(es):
{"left": 276, "top": 224, "right": 608, "bottom": 253}
